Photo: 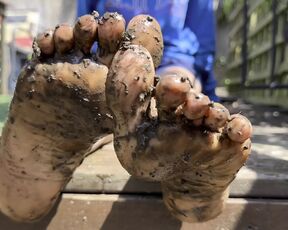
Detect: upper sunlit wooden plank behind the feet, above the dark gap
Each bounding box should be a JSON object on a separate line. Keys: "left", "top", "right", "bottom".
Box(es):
{"left": 65, "top": 126, "right": 288, "bottom": 197}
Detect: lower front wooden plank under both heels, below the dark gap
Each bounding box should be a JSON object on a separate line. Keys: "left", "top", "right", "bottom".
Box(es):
{"left": 0, "top": 194, "right": 288, "bottom": 230}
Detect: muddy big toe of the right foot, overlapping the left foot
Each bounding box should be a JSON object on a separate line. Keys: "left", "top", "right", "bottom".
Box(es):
{"left": 106, "top": 45, "right": 155, "bottom": 131}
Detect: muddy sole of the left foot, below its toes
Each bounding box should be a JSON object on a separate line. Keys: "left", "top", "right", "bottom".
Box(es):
{"left": 0, "top": 59, "right": 111, "bottom": 220}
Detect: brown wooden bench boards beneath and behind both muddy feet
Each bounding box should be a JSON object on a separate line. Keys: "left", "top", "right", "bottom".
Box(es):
{"left": 0, "top": 126, "right": 288, "bottom": 230}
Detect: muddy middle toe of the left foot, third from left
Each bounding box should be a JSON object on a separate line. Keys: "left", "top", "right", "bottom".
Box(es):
{"left": 73, "top": 11, "right": 98, "bottom": 54}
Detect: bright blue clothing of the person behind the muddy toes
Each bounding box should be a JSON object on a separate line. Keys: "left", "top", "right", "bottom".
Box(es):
{"left": 78, "top": 0, "right": 218, "bottom": 101}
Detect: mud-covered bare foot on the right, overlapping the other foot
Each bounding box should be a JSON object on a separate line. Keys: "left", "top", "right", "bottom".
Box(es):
{"left": 106, "top": 45, "right": 252, "bottom": 222}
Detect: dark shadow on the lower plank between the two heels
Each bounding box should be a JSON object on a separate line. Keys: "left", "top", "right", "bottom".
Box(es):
{"left": 101, "top": 178, "right": 182, "bottom": 230}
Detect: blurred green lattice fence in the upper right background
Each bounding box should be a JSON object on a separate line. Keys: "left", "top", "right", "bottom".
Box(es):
{"left": 216, "top": 0, "right": 288, "bottom": 108}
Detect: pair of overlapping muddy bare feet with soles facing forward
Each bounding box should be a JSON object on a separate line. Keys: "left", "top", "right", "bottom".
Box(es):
{"left": 0, "top": 12, "right": 252, "bottom": 222}
